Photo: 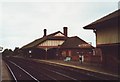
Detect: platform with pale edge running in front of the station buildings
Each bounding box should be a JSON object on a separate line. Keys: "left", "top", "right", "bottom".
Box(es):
{"left": 34, "top": 59, "right": 120, "bottom": 78}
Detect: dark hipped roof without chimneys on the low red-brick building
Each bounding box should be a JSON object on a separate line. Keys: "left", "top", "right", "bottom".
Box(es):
{"left": 60, "top": 36, "right": 93, "bottom": 48}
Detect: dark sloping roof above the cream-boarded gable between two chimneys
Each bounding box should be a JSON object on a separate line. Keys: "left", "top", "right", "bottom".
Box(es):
{"left": 22, "top": 31, "right": 67, "bottom": 49}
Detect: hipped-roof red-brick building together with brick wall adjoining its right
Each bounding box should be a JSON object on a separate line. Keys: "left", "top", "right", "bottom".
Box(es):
{"left": 60, "top": 36, "right": 102, "bottom": 65}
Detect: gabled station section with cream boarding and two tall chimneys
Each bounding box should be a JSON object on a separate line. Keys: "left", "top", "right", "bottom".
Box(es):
{"left": 22, "top": 27, "right": 68, "bottom": 59}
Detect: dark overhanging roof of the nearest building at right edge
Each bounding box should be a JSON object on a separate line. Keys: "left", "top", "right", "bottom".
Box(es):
{"left": 83, "top": 9, "right": 120, "bottom": 29}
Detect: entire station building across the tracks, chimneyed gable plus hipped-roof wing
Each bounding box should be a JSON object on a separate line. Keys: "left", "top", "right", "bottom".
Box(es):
{"left": 21, "top": 27, "right": 94, "bottom": 62}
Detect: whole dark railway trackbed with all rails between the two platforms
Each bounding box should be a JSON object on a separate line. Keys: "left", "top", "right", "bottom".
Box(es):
{"left": 4, "top": 58, "right": 119, "bottom": 82}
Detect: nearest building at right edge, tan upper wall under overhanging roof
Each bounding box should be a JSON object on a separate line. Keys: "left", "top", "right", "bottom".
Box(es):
{"left": 83, "top": 9, "right": 120, "bottom": 71}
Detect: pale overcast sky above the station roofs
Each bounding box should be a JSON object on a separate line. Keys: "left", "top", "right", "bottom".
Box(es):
{"left": 0, "top": 0, "right": 119, "bottom": 50}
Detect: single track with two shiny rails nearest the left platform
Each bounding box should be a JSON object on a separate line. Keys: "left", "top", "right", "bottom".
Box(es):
{"left": 6, "top": 61, "right": 40, "bottom": 82}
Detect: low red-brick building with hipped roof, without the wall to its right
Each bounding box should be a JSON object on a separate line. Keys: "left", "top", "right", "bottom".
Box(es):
{"left": 60, "top": 36, "right": 94, "bottom": 62}
